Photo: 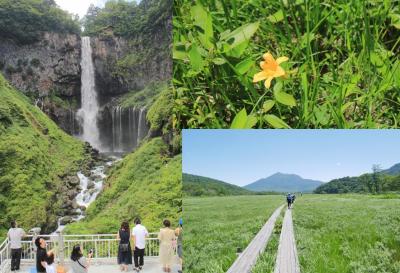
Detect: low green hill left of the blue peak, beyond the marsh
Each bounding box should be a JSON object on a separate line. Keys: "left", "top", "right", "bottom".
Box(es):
{"left": 182, "top": 173, "right": 254, "bottom": 196}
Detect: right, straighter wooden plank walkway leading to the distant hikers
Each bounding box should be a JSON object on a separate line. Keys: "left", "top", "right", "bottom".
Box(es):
{"left": 274, "top": 209, "right": 300, "bottom": 273}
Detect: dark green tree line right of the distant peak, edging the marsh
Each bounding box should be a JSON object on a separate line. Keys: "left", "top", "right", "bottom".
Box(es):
{"left": 314, "top": 165, "right": 400, "bottom": 194}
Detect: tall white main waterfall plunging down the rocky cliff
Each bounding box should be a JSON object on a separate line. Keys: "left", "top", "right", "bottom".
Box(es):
{"left": 77, "top": 37, "right": 101, "bottom": 150}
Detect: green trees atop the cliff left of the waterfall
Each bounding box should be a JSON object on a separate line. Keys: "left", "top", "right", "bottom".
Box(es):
{"left": 0, "top": 0, "right": 80, "bottom": 44}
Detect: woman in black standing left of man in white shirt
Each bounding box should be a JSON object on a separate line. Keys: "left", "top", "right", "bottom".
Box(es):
{"left": 117, "top": 222, "right": 132, "bottom": 271}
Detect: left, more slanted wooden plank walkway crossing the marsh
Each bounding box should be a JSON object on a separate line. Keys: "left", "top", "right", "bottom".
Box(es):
{"left": 227, "top": 205, "right": 283, "bottom": 273}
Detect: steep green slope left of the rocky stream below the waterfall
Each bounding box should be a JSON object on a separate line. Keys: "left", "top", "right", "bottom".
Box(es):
{"left": 0, "top": 75, "right": 85, "bottom": 234}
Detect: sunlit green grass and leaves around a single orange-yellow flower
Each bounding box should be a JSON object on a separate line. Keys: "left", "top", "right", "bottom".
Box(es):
{"left": 173, "top": 0, "right": 400, "bottom": 128}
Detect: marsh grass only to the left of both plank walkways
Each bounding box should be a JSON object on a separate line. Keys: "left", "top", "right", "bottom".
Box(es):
{"left": 183, "top": 195, "right": 283, "bottom": 273}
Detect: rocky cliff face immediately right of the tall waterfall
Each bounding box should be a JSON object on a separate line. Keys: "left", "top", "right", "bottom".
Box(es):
{"left": 92, "top": 17, "right": 172, "bottom": 100}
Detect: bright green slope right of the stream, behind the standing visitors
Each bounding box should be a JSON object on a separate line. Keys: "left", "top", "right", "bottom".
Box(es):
{"left": 67, "top": 138, "right": 182, "bottom": 234}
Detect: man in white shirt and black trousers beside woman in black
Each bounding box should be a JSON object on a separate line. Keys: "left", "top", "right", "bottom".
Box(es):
{"left": 132, "top": 218, "right": 149, "bottom": 272}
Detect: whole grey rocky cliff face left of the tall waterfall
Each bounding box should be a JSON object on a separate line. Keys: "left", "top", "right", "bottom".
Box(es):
{"left": 0, "top": 32, "right": 81, "bottom": 134}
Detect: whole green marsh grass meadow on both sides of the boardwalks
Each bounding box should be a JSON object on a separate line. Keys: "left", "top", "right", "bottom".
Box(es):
{"left": 184, "top": 194, "right": 400, "bottom": 273}
